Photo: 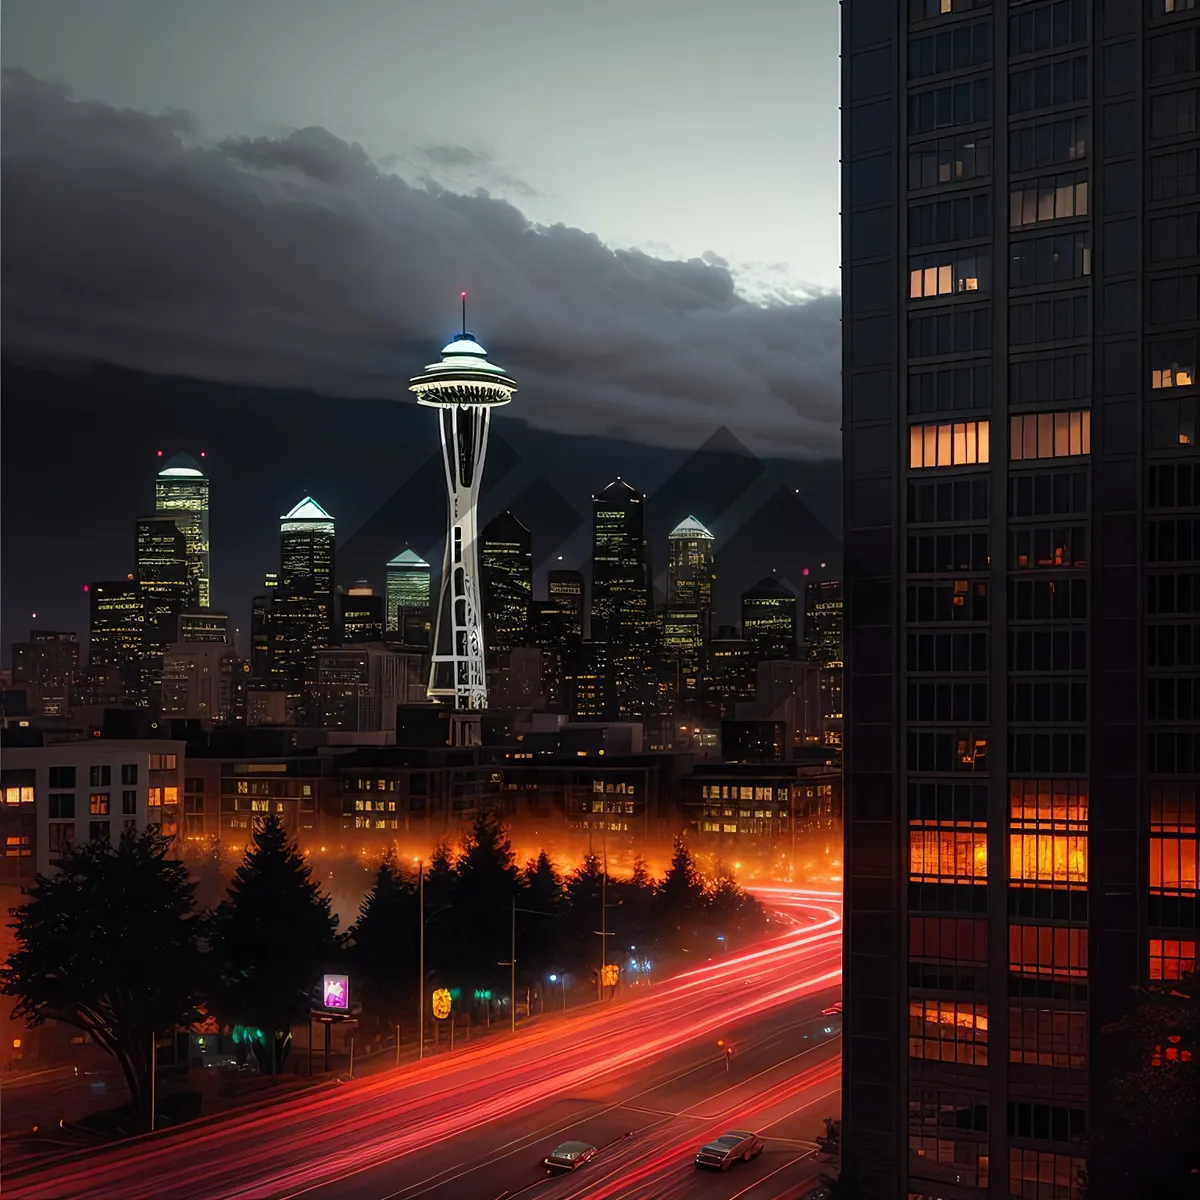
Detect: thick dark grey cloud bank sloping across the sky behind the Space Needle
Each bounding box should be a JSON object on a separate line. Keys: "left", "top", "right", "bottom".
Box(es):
{"left": 0, "top": 72, "right": 839, "bottom": 457}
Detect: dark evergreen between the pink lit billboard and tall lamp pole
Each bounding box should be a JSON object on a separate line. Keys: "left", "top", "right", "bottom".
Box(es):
{"left": 348, "top": 848, "right": 420, "bottom": 1028}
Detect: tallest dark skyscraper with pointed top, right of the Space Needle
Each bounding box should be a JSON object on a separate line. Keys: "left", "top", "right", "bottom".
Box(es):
{"left": 590, "top": 475, "right": 649, "bottom": 641}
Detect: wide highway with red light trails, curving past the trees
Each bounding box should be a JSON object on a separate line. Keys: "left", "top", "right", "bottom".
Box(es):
{"left": 5, "top": 888, "right": 841, "bottom": 1200}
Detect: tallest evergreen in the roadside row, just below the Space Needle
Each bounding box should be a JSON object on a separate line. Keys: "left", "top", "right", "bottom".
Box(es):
{"left": 454, "top": 815, "right": 517, "bottom": 986}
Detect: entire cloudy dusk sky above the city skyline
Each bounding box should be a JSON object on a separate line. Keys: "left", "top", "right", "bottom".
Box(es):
{"left": 0, "top": 0, "right": 840, "bottom": 657}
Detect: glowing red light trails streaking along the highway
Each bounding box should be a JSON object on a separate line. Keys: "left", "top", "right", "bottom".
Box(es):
{"left": 6, "top": 888, "right": 841, "bottom": 1200}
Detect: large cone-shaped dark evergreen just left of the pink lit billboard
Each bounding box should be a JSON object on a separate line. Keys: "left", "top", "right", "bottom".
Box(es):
{"left": 211, "top": 816, "right": 341, "bottom": 1074}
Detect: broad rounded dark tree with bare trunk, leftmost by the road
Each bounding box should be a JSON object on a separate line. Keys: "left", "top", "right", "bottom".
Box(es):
{"left": 0, "top": 829, "right": 206, "bottom": 1120}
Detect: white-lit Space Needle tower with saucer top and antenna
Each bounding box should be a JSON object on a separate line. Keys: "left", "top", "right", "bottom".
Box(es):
{"left": 408, "top": 292, "right": 517, "bottom": 710}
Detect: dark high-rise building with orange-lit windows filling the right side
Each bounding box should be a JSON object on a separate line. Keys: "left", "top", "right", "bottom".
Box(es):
{"left": 841, "top": 0, "right": 1200, "bottom": 1198}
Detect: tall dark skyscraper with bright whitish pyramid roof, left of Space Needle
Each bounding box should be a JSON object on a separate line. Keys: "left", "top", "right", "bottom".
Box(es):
{"left": 270, "top": 496, "right": 336, "bottom": 689}
